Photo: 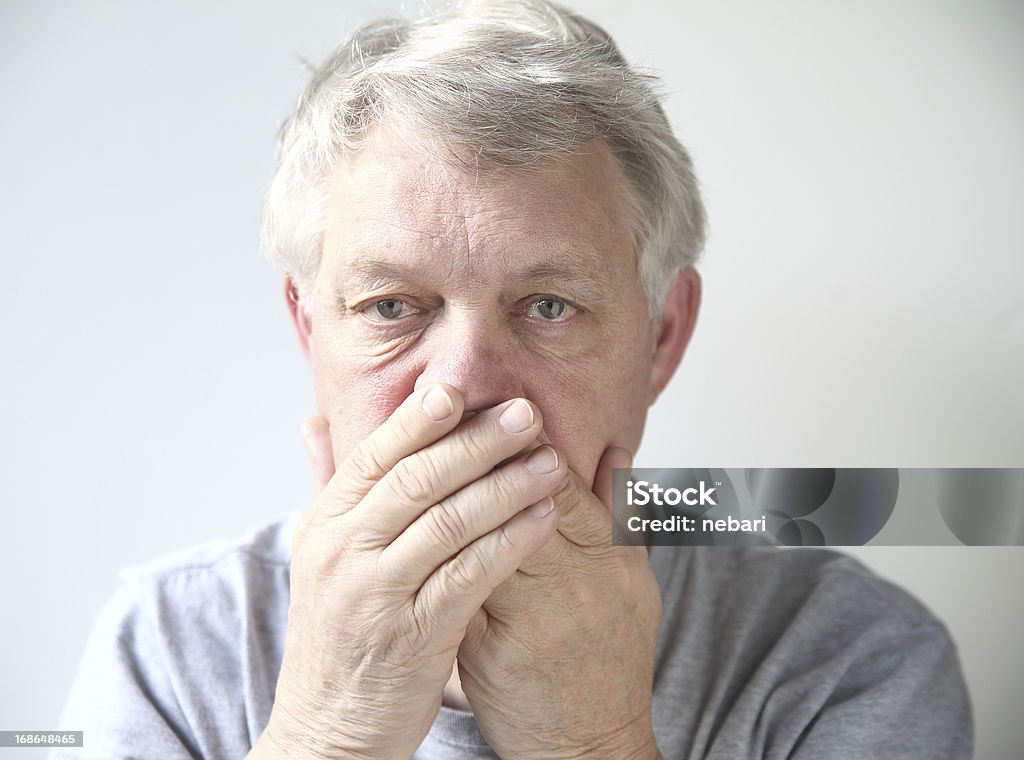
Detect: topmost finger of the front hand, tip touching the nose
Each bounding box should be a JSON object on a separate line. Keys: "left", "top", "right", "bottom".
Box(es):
{"left": 319, "top": 383, "right": 464, "bottom": 517}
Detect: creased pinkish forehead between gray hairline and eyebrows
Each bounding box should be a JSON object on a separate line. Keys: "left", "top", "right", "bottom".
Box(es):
{"left": 327, "top": 132, "right": 635, "bottom": 299}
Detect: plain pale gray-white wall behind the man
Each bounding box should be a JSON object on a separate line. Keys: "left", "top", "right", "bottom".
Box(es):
{"left": 0, "top": 0, "right": 1024, "bottom": 758}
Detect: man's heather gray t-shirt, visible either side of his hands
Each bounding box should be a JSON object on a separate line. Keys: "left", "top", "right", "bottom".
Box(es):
{"left": 50, "top": 513, "right": 973, "bottom": 760}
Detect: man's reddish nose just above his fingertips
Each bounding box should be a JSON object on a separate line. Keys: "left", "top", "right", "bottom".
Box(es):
{"left": 416, "top": 320, "right": 525, "bottom": 412}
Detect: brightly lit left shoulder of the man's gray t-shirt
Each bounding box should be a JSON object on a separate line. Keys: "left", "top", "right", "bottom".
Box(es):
{"left": 62, "top": 513, "right": 298, "bottom": 757}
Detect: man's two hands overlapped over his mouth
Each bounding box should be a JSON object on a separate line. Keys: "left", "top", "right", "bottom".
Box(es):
{"left": 256, "top": 383, "right": 660, "bottom": 760}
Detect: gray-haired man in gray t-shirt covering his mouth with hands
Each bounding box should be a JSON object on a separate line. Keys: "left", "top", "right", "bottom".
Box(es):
{"left": 56, "top": 2, "right": 972, "bottom": 760}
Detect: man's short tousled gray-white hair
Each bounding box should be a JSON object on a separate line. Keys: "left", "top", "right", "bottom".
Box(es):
{"left": 261, "top": 0, "right": 705, "bottom": 319}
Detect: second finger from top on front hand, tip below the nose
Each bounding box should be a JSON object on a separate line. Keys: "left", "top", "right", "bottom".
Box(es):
{"left": 352, "top": 398, "right": 554, "bottom": 544}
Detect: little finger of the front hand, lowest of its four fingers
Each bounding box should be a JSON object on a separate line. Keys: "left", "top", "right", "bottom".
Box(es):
{"left": 414, "top": 499, "right": 558, "bottom": 643}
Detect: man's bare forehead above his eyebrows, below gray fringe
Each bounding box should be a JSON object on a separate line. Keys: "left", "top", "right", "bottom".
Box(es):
{"left": 325, "top": 131, "right": 633, "bottom": 286}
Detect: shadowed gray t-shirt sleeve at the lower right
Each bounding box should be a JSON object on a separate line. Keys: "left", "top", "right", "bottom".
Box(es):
{"left": 791, "top": 622, "right": 974, "bottom": 760}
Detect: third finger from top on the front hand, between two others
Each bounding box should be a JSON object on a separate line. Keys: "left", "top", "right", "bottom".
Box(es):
{"left": 381, "top": 447, "right": 566, "bottom": 587}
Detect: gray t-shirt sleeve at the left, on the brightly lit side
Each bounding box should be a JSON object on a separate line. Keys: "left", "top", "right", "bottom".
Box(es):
{"left": 48, "top": 576, "right": 200, "bottom": 760}
